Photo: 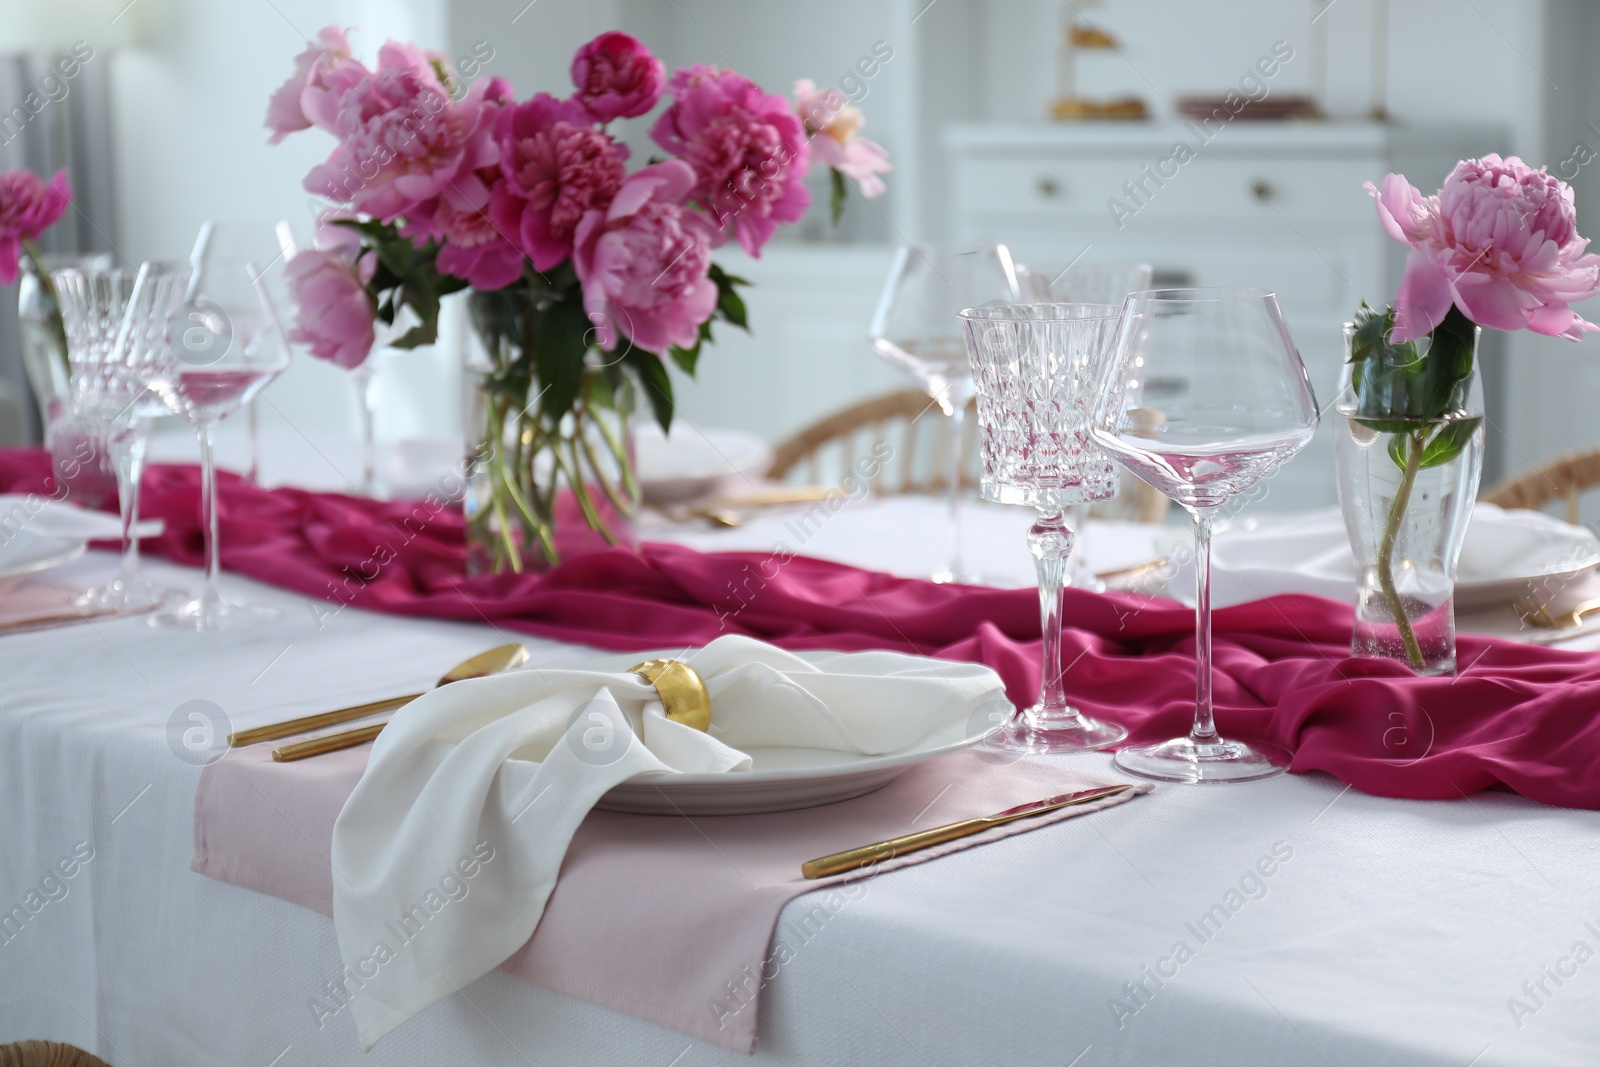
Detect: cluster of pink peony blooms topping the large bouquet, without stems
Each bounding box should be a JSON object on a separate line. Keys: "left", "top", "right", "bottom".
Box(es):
{"left": 267, "top": 27, "right": 890, "bottom": 399}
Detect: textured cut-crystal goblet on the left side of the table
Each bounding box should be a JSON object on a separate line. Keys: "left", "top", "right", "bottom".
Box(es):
{"left": 51, "top": 264, "right": 189, "bottom": 611}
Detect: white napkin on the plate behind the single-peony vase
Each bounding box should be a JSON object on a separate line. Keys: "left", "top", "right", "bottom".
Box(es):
{"left": 1166, "top": 504, "right": 1600, "bottom": 608}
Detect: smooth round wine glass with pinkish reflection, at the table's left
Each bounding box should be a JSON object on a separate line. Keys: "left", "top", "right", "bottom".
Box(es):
{"left": 150, "top": 261, "right": 290, "bottom": 630}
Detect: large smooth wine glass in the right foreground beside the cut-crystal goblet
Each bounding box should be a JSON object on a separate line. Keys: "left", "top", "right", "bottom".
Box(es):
{"left": 1091, "top": 290, "right": 1317, "bottom": 782}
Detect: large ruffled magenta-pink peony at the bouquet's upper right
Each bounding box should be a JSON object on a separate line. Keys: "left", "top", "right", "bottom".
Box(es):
{"left": 650, "top": 66, "right": 811, "bottom": 256}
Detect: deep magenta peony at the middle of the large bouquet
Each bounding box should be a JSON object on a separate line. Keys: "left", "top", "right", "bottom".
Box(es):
{"left": 491, "top": 93, "right": 627, "bottom": 270}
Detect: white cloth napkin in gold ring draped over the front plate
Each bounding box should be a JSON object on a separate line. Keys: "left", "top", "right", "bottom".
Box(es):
{"left": 331, "top": 635, "right": 1005, "bottom": 1048}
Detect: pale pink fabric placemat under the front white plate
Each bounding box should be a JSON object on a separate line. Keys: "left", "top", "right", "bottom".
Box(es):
{"left": 192, "top": 745, "right": 1149, "bottom": 1053}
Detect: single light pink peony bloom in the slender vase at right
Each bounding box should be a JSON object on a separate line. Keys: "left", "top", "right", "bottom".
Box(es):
{"left": 1366, "top": 154, "right": 1600, "bottom": 341}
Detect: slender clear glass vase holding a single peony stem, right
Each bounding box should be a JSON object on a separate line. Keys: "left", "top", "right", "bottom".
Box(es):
{"left": 1334, "top": 326, "right": 1483, "bottom": 675}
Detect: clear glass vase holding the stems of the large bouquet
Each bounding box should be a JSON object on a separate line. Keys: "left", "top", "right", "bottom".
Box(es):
{"left": 462, "top": 290, "right": 640, "bottom": 574}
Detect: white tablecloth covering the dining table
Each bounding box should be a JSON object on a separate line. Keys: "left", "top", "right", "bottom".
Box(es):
{"left": 0, "top": 486, "right": 1600, "bottom": 1067}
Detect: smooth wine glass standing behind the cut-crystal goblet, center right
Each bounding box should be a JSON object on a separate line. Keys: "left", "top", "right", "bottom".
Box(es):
{"left": 870, "top": 245, "right": 1019, "bottom": 582}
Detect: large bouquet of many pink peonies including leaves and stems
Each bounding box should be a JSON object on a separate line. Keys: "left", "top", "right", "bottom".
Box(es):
{"left": 267, "top": 27, "right": 890, "bottom": 569}
